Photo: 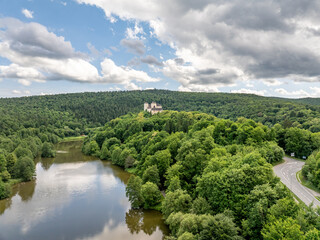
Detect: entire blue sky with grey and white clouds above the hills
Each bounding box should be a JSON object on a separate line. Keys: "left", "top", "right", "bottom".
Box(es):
{"left": 0, "top": 0, "right": 320, "bottom": 98}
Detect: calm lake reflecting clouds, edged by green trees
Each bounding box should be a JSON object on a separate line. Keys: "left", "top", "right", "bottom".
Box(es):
{"left": 0, "top": 142, "right": 168, "bottom": 240}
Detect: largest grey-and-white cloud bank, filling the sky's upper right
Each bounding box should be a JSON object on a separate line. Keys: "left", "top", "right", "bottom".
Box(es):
{"left": 77, "top": 0, "right": 320, "bottom": 91}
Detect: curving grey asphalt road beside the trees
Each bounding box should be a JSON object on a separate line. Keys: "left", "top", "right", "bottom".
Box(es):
{"left": 273, "top": 157, "right": 320, "bottom": 207}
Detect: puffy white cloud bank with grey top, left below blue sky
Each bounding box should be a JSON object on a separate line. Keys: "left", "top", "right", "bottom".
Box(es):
{"left": 0, "top": 18, "right": 159, "bottom": 88}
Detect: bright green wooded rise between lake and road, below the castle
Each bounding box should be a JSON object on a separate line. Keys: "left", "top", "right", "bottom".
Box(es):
{"left": 83, "top": 111, "right": 320, "bottom": 240}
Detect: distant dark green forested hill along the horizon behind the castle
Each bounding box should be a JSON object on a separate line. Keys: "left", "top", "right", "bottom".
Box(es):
{"left": 0, "top": 90, "right": 320, "bottom": 132}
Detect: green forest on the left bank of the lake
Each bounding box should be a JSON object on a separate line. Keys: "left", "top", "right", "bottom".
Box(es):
{"left": 0, "top": 99, "right": 88, "bottom": 199}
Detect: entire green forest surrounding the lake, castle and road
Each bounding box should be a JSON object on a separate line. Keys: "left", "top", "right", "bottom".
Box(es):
{"left": 0, "top": 90, "right": 320, "bottom": 240}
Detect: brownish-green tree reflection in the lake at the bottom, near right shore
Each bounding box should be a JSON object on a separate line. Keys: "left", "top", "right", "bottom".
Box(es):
{"left": 126, "top": 209, "right": 168, "bottom": 235}
